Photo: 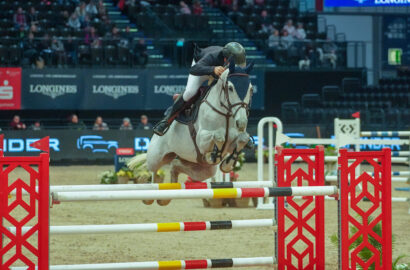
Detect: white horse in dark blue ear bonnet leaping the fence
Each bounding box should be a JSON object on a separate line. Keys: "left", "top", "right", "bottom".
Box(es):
{"left": 129, "top": 62, "right": 253, "bottom": 205}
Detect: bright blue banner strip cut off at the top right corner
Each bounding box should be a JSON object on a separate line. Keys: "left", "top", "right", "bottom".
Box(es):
{"left": 325, "top": 0, "right": 410, "bottom": 7}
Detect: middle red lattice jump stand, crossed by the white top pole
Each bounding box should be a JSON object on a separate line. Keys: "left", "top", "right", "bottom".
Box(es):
{"left": 275, "top": 147, "right": 325, "bottom": 270}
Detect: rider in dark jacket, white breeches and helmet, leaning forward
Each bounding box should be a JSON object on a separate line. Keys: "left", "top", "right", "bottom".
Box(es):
{"left": 154, "top": 42, "right": 246, "bottom": 136}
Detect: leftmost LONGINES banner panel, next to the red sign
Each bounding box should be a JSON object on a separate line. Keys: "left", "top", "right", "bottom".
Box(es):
{"left": 22, "top": 69, "right": 84, "bottom": 110}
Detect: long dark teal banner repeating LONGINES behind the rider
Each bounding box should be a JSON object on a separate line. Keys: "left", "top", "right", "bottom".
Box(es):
{"left": 22, "top": 69, "right": 265, "bottom": 110}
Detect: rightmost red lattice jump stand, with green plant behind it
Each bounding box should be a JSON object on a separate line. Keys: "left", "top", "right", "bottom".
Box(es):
{"left": 339, "top": 149, "right": 392, "bottom": 270}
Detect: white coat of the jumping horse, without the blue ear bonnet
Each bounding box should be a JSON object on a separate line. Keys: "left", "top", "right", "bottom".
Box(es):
{"left": 130, "top": 66, "right": 252, "bottom": 196}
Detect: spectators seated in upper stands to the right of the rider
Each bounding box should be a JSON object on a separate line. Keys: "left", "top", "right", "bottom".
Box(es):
{"left": 223, "top": 0, "right": 345, "bottom": 69}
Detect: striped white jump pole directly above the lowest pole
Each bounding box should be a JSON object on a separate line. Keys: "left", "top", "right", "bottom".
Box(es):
{"left": 7, "top": 219, "right": 276, "bottom": 235}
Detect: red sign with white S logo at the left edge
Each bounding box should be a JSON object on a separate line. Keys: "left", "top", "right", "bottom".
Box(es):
{"left": 0, "top": 68, "right": 21, "bottom": 110}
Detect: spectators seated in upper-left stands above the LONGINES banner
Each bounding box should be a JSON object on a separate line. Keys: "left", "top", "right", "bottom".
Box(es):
{"left": 3, "top": 0, "right": 148, "bottom": 68}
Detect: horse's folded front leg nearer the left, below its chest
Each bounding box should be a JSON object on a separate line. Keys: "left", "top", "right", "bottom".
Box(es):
{"left": 197, "top": 128, "right": 225, "bottom": 164}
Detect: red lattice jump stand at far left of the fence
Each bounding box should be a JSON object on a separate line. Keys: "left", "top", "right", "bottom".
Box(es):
{"left": 0, "top": 153, "right": 50, "bottom": 270}
